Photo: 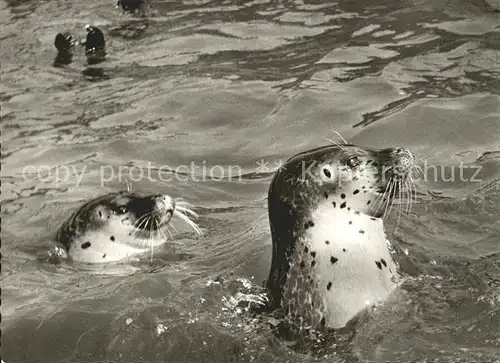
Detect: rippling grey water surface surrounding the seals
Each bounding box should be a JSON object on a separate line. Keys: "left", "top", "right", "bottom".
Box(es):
{"left": 0, "top": 0, "right": 500, "bottom": 363}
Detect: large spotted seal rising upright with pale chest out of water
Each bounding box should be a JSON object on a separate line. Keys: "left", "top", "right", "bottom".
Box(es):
{"left": 267, "top": 144, "right": 414, "bottom": 329}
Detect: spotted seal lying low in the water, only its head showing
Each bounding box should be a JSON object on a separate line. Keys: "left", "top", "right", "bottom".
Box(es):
{"left": 56, "top": 191, "right": 201, "bottom": 263}
